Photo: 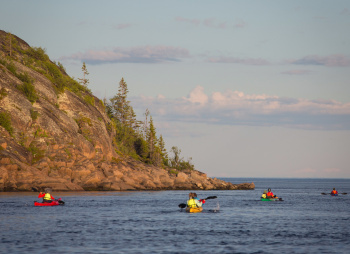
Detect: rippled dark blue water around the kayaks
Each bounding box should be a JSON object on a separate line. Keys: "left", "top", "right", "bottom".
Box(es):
{"left": 0, "top": 178, "right": 350, "bottom": 254}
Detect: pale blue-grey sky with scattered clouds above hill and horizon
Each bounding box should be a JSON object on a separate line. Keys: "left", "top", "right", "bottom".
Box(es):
{"left": 0, "top": 0, "right": 350, "bottom": 178}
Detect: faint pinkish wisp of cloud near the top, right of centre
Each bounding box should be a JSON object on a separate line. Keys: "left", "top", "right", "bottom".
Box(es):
{"left": 175, "top": 17, "right": 246, "bottom": 29}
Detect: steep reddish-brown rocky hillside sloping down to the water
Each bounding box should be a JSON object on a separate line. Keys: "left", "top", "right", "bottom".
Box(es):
{"left": 0, "top": 30, "right": 254, "bottom": 191}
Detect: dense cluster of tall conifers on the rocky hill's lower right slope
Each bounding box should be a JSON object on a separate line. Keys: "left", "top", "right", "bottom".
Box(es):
{"left": 105, "top": 78, "right": 194, "bottom": 171}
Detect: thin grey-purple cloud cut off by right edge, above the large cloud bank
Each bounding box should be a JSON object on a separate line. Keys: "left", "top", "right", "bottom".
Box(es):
{"left": 290, "top": 54, "right": 350, "bottom": 67}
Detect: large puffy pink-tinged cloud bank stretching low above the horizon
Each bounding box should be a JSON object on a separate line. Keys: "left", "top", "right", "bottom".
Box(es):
{"left": 132, "top": 86, "right": 350, "bottom": 130}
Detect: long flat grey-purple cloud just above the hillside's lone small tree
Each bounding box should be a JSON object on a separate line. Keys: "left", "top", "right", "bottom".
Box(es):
{"left": 61, "top": 46, "right": 190, "bottom": 64}
